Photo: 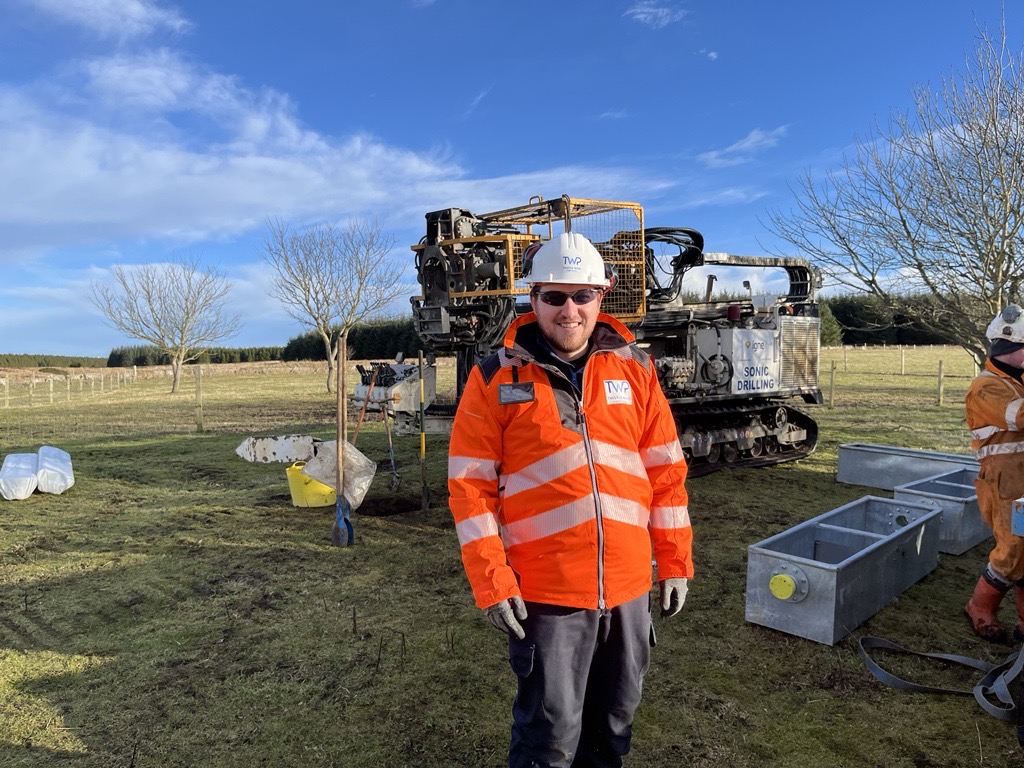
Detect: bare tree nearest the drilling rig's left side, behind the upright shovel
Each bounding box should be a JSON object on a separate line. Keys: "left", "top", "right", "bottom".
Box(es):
{"left": 260, "top": 220, "right": 402, "bottom": 392}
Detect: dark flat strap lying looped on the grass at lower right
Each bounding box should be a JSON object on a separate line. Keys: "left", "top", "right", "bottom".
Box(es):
{"left": 857, "top": 637, "right": 1024, "bottom": 724}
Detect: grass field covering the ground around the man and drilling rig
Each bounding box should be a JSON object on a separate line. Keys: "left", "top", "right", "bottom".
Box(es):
{"left": 0, "top": 348, "right": 1024, "bottom": 768}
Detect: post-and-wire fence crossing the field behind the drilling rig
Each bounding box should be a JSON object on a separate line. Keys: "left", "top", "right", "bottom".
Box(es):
{"left": 0, "top": 346, "right": 978, "bottom": 449}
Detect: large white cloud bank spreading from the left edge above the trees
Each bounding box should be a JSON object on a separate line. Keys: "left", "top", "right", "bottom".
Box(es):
{"left": 0, "top": 41, "right": 462, "bottom": 262}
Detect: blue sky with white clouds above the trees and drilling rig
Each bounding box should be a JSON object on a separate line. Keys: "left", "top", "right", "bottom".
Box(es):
{"left": 0, "top": 0, "right": 1024, "bottom": 356}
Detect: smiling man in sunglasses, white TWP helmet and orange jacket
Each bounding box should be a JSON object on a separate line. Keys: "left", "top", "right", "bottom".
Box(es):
{"left": 449, "top": 232, "right": 693, "bottom": 768}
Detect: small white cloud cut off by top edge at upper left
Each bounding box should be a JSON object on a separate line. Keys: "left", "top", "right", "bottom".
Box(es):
{"left": 24, "top": 0, "right": 190, "bottom": 39}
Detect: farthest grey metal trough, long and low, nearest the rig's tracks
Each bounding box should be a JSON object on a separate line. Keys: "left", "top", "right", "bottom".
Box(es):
{"left": 836, "top": 442, "right": 978, "bottom": 490}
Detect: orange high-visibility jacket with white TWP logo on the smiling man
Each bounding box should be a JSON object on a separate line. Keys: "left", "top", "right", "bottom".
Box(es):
{"left": 449, "top": 313, "right": 693, "bottom": 608}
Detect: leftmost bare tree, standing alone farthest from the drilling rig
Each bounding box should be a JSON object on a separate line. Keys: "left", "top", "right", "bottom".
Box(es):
{"left": 90, "top": 256, "right": 240, "bottom": 392}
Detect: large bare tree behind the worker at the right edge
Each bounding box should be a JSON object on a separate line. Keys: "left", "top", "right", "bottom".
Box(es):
{"left": 769, "top": 29, "right": 1024, "bottom": 362}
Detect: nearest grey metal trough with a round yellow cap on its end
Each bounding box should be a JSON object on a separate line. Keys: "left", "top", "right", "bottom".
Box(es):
{"left": 746, "top": 496, "right": 942, "bottom": 645}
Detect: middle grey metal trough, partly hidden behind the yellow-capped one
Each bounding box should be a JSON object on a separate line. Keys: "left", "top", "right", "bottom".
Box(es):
{"left": 893, "top": 469, "right": 992, "bottom": 555}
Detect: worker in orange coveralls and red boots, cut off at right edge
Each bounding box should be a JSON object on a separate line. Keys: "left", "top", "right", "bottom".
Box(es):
{"left": 964, "top": 304, "right": 1024, "bottom": 642}
